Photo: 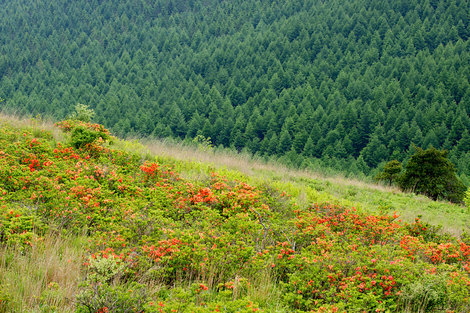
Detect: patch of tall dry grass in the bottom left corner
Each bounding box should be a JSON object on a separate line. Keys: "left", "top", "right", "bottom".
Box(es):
{"left": 0, "top": 235, "right": 83, "bottom": 312}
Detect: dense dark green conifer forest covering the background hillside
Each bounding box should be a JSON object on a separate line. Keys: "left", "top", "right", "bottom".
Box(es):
{"left": 0, "top": 0, "right": 470, "bottom": 178}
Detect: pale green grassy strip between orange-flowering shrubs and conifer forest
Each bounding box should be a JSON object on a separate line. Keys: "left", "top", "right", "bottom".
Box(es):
{"left": 142, "top": 141, "right": 470, "bottom": 235}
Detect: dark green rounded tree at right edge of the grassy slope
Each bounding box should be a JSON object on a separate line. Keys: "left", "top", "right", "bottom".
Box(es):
{"left": 400, "top": 147, "right": 466, "bottom": 202}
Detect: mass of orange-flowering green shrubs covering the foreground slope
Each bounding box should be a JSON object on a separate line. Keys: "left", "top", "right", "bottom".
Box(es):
{"left": 0, "top": 121, "right": 470, "bottom": 312}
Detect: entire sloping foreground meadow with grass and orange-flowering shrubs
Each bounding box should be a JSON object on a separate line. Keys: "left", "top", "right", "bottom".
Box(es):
{"left": 0, "top": 117, "right": 470, "bottom": 312}
